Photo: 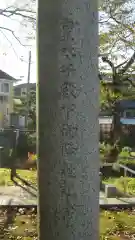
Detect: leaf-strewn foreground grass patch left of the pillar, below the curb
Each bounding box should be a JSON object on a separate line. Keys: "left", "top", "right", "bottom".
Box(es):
{"left": 0, "top": 207, "right": 38, "bottom": 240}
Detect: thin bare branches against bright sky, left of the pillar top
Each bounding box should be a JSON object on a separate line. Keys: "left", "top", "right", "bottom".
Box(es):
{"left": 0, "top": 0, "right": 36, "bottom": 57}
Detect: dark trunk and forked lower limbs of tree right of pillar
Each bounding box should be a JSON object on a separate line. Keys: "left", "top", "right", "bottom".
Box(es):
{"left": 100, "top": 53, "right": 135, "bottom": 162}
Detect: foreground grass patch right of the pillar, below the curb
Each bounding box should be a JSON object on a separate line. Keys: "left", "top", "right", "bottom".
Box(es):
{"left": 100, "top": 209, "right": 135, "bottom": 240}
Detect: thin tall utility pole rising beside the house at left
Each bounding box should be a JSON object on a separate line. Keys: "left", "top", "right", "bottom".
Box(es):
{"left": 26, "top": 51, "right": 31, "bottom": 127}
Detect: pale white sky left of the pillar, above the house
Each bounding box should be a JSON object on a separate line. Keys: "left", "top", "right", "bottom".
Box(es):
{"left": 0, "top": 0, "right": 36, "bottom": 83}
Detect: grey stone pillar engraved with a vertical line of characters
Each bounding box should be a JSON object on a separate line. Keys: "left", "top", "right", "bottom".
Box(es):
{"left": 37, "top": 0, "right": 99, "bottom": 240}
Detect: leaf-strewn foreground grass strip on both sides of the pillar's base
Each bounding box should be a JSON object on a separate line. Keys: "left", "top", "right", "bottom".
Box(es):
{"left": 0, "top": 208, "right": 135, "bottom": 240}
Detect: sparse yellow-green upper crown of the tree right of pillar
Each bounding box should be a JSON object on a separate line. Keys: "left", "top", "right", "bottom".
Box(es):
{"left": 99, "top": 0, "right": 135, "bottom": 62}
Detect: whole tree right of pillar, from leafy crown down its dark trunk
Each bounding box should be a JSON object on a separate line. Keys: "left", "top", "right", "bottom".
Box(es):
{"left": 99, "top": 0, "right": 135, "bottom": 159}
